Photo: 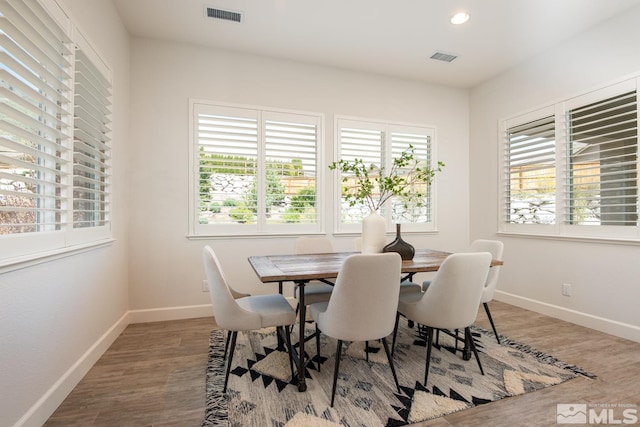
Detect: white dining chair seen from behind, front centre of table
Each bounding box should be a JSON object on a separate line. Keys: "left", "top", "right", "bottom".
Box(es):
{"left": 309, "top": 252, "right": 402, "bottom": 406}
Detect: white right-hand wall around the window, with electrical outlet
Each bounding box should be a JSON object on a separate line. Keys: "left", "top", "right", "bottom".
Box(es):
{"left": 470, "top": 8, "right": 640, "bottom": 341}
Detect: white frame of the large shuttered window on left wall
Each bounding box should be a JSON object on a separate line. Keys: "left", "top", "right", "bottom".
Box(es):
{"left": 0, "top": 0, "right": 113, "bottom": 270}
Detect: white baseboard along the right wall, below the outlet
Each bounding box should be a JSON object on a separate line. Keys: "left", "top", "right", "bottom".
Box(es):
{"left": 494, "top": 290, "right": 640, "bottom": 342}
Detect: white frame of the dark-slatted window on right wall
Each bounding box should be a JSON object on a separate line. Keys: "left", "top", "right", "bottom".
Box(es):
{"left": 498, "top": 77, "right": 640, "bottom": 243}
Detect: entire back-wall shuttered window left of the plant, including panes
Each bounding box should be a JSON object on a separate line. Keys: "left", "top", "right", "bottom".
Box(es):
{"left": 190, "top": 101, "right": 322, "bottom": 235}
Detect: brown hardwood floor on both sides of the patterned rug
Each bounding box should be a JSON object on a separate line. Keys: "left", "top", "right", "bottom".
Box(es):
{"left": 45, "top": 301, "right": 640, "bottom": 427}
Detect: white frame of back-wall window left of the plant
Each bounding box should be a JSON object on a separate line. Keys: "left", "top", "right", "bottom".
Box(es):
{"left": 187, "top": 98, "right": 325, "bottom": 238}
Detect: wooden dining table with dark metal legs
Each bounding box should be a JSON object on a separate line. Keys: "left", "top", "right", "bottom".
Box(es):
{"left": 248, "top": 249, "right": 503, "bottom": 392}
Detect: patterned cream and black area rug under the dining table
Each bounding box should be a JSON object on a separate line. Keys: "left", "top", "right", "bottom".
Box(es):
{"left": 202, "top": 319, "right": 595, "bottom": 427}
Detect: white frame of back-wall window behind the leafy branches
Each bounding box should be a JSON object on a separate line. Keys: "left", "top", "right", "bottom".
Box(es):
{"left": 332, "top": 115, "right": 438, "bottom": 234}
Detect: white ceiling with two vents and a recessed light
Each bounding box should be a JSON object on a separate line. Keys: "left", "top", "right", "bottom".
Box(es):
{"left": 113, "top": 0, "right": 640, "bottom": 88}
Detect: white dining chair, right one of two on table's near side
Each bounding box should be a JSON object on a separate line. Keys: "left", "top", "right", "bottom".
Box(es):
{"left": 392, "top": 252, "right": 491, "bottom": 387}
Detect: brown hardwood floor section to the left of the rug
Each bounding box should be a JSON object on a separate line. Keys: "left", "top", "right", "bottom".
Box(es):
{"left": 45, "top": 317, "right": 216, "bottom": 427}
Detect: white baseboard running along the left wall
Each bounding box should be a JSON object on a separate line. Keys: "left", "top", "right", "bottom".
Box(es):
{"left": 13, "top": 312, "right": 129, "bottom": 427}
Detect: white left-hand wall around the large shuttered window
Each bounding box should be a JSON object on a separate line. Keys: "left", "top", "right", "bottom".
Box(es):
{"left": 0, "top": 0, "right": 129, "bottom": 426}
